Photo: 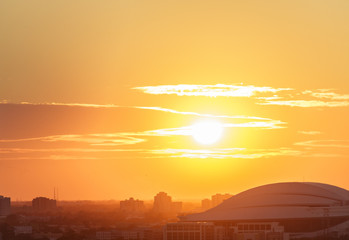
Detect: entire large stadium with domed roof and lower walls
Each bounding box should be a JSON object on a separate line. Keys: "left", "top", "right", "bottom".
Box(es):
{"left": 164, "top": 182, "right": 349, "bottom": 240}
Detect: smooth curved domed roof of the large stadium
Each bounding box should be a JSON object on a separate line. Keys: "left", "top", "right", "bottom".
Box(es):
{"left": 181, "top": 182, "right": 349, "bottom": 222}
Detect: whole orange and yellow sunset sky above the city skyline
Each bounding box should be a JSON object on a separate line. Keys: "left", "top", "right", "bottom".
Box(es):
{"left": 0, "top": 0, "right": 349, "bottom": 200}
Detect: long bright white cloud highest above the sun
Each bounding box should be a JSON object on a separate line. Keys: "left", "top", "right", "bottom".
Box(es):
{"left": 133, "top": 84, "right": 291, "bottom": 97}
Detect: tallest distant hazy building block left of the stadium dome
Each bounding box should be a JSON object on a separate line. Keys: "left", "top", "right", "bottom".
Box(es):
{"left": 153, "top": 192, "right": 182, "bottom": 214}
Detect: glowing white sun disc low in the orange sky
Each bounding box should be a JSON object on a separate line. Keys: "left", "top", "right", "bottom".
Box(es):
{"left": 192, "top": 120, "right": 223, "bottom": 145}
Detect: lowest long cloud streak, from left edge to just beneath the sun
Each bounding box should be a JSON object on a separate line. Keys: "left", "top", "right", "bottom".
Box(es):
{"left": 0, "top": 145, "right": 302, "bottom": 160}
